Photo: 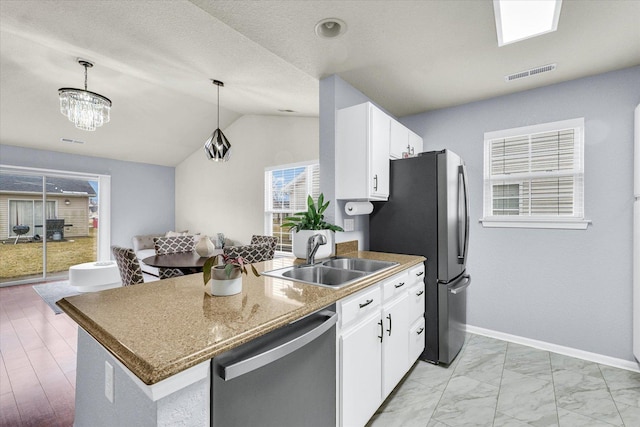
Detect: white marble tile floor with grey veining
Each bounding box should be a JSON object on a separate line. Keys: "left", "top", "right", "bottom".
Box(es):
{"left": 367, "top": 334, "right": 640, "bottom": 427}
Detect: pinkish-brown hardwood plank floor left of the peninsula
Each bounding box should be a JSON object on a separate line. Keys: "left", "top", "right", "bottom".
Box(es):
{"left": 0, "top": 284, "right": 78, "bottom": 427}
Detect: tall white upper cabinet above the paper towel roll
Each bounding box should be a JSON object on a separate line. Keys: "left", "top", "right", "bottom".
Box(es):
{"left": 335, "top": 102, "right": 393, "bottom": 200}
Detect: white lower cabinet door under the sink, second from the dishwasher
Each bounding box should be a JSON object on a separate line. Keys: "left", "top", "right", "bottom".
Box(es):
{"left": 382, "top": 292, "right": 410, "bottom": 398}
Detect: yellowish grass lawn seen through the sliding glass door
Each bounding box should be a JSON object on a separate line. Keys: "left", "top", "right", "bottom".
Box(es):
{"left": 0, "top": 228, "right": 97, "bottom": 282}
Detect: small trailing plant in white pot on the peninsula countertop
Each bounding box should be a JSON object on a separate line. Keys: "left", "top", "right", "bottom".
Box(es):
{"left": 202, "top": 254, "right": 260, "bottom": 295}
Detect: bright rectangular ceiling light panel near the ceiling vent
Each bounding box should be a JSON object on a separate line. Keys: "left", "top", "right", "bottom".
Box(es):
{"left": 493, "top": 0, "right": 562, "bottom": 46}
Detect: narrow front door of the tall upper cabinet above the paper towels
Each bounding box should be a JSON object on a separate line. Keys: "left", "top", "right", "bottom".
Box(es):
{"left": 369, "top": 106, "right": 391, "bottom": 200}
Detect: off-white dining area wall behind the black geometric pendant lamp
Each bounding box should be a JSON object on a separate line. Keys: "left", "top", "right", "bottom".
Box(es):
{"left": 176, "top": 115, "right": 323, "bottom": 244}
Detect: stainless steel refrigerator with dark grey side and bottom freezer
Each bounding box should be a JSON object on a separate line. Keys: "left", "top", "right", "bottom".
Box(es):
{"left": 369, "top": 150, "right": 471, "bottom": 364}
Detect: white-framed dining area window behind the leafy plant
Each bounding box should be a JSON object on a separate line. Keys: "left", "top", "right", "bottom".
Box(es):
{"left": 264, "top": 162, "right": 320, "bottom": 253}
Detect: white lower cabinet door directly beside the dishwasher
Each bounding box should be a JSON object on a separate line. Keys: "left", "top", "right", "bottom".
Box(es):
{"left": 340, "top": 312, "right": 382, "bottom": 427}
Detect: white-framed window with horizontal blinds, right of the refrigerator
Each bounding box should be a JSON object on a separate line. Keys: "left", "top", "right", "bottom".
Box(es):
{"left": 482, "top": 118, "right": 589, "bottom": 229}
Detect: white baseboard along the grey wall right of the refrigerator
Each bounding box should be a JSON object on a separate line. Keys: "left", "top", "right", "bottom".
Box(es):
{"left": 467, "top": 325, "right": 640, "bottom": 372}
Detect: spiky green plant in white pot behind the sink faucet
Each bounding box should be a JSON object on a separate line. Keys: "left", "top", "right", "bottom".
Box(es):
{"left": 282, "top": 193, "right": 344, "bottom": 258}
